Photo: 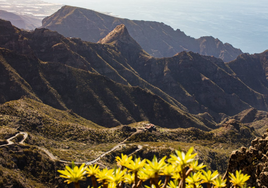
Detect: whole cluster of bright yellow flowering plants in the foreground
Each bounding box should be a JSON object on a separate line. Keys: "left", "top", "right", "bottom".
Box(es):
{"left": 58, "top": 147, "right": 250, "bottom": 188}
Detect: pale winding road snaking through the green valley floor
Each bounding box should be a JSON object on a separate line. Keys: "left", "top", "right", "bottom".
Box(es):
{"left": 0, "top": 129, "right": 144, "bottom": 165}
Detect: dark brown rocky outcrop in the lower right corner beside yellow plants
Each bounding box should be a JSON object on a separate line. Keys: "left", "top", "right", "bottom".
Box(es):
{"left": 227, "top": 133, "right": 268, "bottom": 187}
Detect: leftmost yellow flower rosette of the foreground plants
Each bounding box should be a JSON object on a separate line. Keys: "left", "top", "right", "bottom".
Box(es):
{"left": 58, "top": 163, "right": 86, "bottom": 184}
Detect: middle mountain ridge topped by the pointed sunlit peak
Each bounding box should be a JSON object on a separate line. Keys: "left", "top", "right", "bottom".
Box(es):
{"left": 0, "top": 18, "right": 267, "bottom": 123}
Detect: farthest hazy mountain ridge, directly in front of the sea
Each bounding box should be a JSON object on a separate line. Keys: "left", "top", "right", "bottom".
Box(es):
{"left": 42, "top": 6, "right": 242, "bottom": 62}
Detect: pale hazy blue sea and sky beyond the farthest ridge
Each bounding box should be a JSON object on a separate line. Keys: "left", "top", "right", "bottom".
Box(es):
{"left": 43, "top": 0, "right": 268, "bottom": 53}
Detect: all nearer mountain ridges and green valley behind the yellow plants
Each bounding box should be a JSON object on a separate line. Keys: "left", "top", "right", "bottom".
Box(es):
{"left": 0, "top": 17, "right": 268, "bottom": 187}
